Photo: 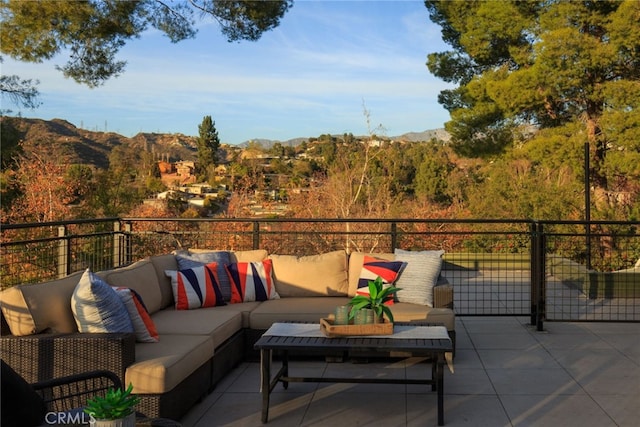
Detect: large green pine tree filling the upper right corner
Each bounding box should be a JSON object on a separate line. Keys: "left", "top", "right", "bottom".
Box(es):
{"left": 425, "top": 0, "right": 640, "bottom": 205}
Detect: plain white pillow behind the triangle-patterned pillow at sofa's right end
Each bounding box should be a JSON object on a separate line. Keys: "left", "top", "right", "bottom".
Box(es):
{"left": 394, "top": 249, "right": 444, "bottom": 307}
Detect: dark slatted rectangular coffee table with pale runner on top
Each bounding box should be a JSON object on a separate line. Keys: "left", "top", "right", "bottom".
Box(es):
{"left": 254, "top": 322, "right": 453, "bottom": 426}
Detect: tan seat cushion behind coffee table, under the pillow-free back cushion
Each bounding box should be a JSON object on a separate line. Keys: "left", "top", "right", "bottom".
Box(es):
{"left": 249, "top": 297, "right": 351, "bottom": 329}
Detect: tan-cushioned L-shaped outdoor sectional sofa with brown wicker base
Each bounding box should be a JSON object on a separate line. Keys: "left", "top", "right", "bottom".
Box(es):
{"left": 0, "top": 250, "right": 455, "bottom": 420}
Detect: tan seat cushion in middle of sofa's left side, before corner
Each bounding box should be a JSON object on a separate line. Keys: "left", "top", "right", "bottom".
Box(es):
{"left": 153, "top": 307, "right": 242, "bottom": 348}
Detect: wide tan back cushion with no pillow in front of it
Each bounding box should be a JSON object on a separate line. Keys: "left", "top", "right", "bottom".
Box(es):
{"left": 269, "top": 250, "right": 349, "bottom": 297}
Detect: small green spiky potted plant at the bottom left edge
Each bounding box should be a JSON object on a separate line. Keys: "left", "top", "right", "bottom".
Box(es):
{"left": 84, "top": 383, "right": 140, "bottom": 427}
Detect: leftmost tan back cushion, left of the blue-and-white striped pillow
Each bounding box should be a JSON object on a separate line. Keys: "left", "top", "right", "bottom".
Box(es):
{"left": 0, "top": 271, "right": 83, "bottom": 336}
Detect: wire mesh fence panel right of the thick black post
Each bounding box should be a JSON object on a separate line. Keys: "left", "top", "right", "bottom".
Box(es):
{"left": 545, "top": 224, "right": 640, "bottom": 321}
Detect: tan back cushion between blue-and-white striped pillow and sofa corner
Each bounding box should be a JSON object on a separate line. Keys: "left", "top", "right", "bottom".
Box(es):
{"left": 98, "top": 258, "right": 163, "bottom": 314}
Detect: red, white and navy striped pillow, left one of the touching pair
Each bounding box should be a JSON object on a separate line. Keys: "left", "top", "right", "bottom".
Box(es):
{"left": 165, "top": 262, "right": 226, "bottom": 310}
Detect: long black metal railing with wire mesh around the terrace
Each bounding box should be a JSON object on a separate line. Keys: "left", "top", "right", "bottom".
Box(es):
{"left": 0, "top": 218, "right": 640, "bottom": 329}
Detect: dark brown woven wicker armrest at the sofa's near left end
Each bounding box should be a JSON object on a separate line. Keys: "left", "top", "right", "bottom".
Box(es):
{"left": 0, "top": 333, "right": 135, "bottom": 383}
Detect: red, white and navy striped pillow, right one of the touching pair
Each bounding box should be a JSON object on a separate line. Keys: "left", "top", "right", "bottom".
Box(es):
{"left": 226, "top": 259, "right": 280, "bottom": 304}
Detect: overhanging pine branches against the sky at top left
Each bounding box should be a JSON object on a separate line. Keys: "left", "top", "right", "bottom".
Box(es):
{"left": 0, "top": 0, "right": 293, "bottom": 87}
